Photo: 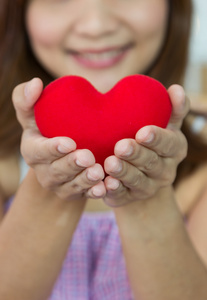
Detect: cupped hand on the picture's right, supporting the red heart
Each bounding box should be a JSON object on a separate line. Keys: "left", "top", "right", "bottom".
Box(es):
{"left": 104, "top": 85, "right": 189, "bottom": 207}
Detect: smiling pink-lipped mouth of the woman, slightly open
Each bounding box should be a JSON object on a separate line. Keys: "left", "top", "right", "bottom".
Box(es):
{"left": 67, "top": 43, "right": 133, "bottom": 69}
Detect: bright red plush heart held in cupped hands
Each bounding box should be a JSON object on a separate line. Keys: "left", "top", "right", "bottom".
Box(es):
{"left": 34, "top": 75, "right": 171, "bottom": 165}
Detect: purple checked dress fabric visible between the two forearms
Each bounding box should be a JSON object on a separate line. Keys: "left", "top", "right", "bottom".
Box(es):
{"left": 48, "top": 212, "right": 133, "bottom": 300}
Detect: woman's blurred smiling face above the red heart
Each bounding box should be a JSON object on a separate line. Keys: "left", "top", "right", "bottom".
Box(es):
{"left": 26, "top": 0, "right": 169, "bottom": 92}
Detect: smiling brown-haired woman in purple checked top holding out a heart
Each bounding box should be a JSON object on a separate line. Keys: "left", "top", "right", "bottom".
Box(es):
{"left": 0, "top": 0, "right": 207, "bottom": 300}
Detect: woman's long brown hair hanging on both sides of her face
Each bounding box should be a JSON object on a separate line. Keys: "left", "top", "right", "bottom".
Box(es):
{"left": 0, "top": 0, "right": 203, "bottom": 182}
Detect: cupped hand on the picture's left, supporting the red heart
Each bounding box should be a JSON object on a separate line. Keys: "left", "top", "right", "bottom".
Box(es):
{"left": 12, "top": 78, "right": 106, "bottom": 200}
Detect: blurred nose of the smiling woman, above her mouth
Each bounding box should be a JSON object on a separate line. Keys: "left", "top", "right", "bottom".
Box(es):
{"left": 74, "top": 0, "right": 119, "bottom": 38}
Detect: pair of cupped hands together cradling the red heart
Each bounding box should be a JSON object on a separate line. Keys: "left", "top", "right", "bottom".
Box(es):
{"left": 13, "top": 78, "right": 188, "bottom": 206}
